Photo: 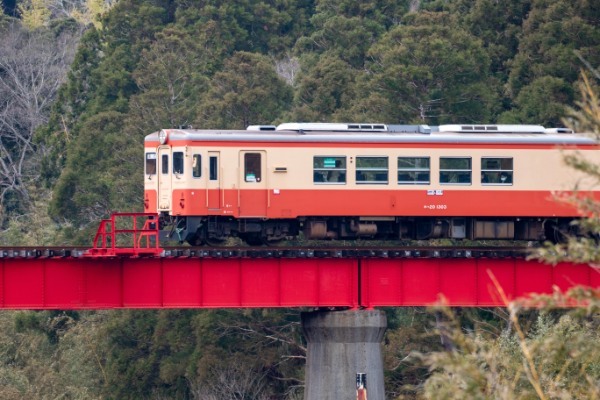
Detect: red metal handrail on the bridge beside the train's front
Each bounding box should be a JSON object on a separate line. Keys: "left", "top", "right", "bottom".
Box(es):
{"left": 84, "top": 213, "right": 163, "bottom": 257}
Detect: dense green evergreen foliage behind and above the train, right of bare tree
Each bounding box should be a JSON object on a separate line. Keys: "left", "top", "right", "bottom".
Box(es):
{"left": 24, "top": 0, "right": 600, "bottom": 240}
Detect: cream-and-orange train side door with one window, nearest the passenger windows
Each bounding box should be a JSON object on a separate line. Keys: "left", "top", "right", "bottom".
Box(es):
{"left": 239, "top": 150, "right": 269, "bottom": 218}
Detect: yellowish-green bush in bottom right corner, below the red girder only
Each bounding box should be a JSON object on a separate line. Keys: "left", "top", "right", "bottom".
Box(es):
{"left": 417, "top": 304, "right": 600, "bottom": 400}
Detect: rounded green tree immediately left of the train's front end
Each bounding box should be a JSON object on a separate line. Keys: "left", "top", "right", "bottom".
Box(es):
{"left": 49, "top": 111, "right": 143, "bottom": 233}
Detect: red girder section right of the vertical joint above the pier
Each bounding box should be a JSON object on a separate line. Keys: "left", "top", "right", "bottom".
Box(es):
{"left": 360, "top": 258, "right": 600, "bottom": 308}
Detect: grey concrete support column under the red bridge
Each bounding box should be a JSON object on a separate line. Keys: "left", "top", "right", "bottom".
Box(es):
{"left": 302, "top": 310, "right": 387, "bottom": 400}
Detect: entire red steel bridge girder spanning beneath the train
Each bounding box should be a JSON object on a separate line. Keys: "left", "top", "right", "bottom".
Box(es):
{"left": 0, "top": 257, "right": 600, "bottom": 309}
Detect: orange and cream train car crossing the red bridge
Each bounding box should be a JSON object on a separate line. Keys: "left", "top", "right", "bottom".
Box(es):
{"left": 144, "top": 123, "right": 600, "bottom": 244}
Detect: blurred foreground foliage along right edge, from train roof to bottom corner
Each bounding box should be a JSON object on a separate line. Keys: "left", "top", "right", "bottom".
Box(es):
{"left": 419, "top": 67, "right": 600, "bottom": 399}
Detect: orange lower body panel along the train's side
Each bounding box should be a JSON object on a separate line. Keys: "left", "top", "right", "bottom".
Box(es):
{"left": 159, "top": 189, "right": 600, "bottom": 218}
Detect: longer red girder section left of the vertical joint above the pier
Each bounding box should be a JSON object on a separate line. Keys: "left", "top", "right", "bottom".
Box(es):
{"left": 0, "top": 257, "right": 358, "bottom": 309}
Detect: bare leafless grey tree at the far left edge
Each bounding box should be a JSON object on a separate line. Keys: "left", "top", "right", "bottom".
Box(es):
{"left": 0, "top": 24, "right": 80, "bottom": 222}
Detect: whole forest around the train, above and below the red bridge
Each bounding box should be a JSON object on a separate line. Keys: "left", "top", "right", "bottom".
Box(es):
{"left": 0, "top": 0, "right": 600, "bottom": 400}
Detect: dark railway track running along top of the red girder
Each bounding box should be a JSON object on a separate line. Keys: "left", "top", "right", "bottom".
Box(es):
{"left": 0, "top": 246, "right": 532, "bottom": 259}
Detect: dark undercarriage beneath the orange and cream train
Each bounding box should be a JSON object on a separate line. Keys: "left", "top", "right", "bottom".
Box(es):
{"left": 160, "top": 215, "right": 577, "bottom": 246}
